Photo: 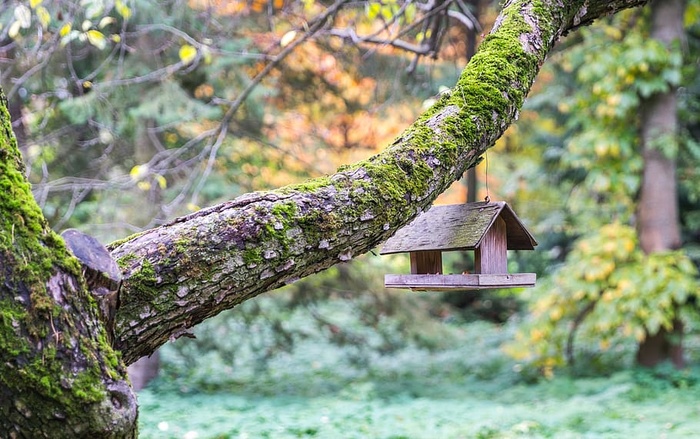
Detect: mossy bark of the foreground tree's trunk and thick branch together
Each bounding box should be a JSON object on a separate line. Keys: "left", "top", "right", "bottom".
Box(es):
{"left": 0, "top": 0, "right": 645, "bottom": 438}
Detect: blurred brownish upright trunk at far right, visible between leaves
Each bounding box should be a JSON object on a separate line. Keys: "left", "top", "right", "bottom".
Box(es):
{"left": 637, "top": 0, "right": 685, "bottom": 368}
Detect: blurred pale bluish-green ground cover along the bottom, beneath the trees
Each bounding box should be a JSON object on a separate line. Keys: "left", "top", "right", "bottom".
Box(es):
{"left": 139, "top": 323, "right": 700, "bottom": 439}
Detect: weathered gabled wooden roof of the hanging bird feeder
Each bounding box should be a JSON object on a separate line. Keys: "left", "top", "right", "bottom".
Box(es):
{"left": 380, "top": 201, "right": 537, "bottom": 254}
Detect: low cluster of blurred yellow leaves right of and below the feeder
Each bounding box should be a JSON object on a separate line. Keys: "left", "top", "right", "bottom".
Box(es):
{"left": 506, "top": 223, "right": 700, "bottom": 376}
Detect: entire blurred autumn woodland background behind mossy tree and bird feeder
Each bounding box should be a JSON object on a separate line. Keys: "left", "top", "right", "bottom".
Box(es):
{"left": 0, "top": 0, "right": 700, "bottom": 439}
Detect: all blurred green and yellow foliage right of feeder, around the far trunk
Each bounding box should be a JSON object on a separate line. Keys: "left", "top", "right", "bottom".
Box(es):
{"left": 492, "top": 1, "right": 700, "bottom": 376}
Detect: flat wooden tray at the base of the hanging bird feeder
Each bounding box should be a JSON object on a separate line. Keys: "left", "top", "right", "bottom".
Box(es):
{"left": 384, "top": 273, "right": 537, "bottom": 291}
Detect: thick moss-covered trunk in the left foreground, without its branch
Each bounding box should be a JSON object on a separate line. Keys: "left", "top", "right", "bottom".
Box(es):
{"left": 0, "top": 91, "right": 136, "bottom": 438}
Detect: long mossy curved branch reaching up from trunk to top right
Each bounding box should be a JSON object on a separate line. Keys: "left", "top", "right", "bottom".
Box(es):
{"left": 112, "top": 0, "right": 645, "bottom": 363}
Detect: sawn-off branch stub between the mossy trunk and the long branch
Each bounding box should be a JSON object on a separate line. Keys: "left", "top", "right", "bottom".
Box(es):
{"left": 61, "top": 229, "right": 122, "bottom": 343}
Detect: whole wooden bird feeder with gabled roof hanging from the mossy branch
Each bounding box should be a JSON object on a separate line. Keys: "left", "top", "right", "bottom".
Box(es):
{"left": 381, "top": 201, "right": 537, "bottom": 291}
